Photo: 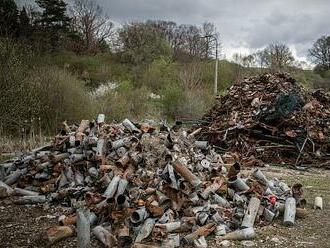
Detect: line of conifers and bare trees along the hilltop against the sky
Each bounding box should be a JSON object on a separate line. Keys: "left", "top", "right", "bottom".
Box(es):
{"left": 0, "top": 0, "right": 330, "bottom": 71}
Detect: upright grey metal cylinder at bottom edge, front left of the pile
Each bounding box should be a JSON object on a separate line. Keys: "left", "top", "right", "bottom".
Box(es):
{"left": 77, "top": 209, "right": 90, "bottom": 248}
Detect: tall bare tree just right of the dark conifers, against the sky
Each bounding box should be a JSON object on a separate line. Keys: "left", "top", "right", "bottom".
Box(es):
{"left": 71, "top": 0, "right": 114, "bottom": 52}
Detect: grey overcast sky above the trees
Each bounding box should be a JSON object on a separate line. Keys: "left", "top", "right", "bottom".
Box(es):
{"left": 18, "top": 0, "right": 330, "bottom": 62}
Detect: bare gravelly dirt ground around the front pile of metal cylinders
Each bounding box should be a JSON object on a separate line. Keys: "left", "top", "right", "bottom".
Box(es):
{"left": 0, "top": 167, "right": 330, "bottom": 248}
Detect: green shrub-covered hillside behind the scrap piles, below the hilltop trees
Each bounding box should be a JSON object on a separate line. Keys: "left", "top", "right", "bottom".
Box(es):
{"left": 0, "top": 38, "right": 330, "bottom": 140}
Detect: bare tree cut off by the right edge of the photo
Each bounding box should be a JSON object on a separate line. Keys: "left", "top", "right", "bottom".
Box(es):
{"left": 309, "top": 36, "right": 330, "bottom": 70}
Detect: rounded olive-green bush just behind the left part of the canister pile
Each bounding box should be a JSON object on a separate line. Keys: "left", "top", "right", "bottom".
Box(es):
{"left": 30, "top": 66, "right": 94, "bottom": 132}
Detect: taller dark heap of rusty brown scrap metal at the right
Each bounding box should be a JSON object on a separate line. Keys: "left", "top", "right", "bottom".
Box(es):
{"left": 200, "top": 71, "right": 330, "bottom": 167}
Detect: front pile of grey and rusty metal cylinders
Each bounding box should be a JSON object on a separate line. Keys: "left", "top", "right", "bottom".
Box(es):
{"left": 0, "top": 115, "right": 306, "bottom": 247}
